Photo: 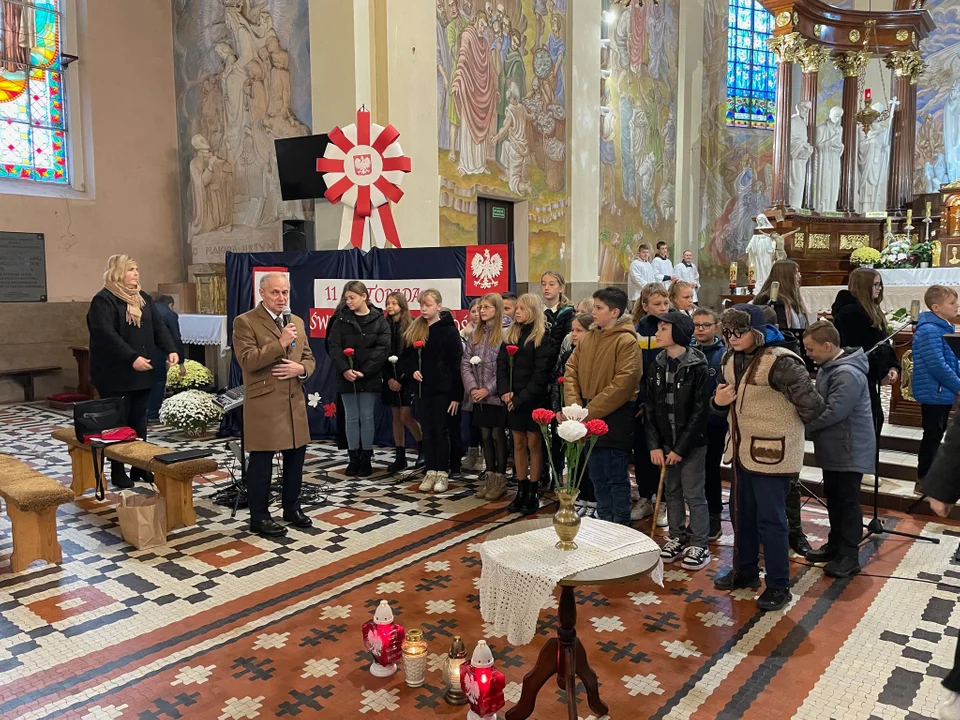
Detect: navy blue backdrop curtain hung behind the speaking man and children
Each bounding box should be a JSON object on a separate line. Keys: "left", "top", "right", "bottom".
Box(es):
{"left": 221, "top": 245, "right": 517, "bottom": 447}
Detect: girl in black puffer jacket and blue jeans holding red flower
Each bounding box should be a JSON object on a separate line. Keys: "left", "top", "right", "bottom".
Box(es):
{"left": 327, "top": 280, "right": 390, "bottom": 477}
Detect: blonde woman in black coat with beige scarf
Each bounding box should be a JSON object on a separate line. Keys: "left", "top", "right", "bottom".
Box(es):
{"left": 87, "top": 255, "right": 180, "bottom": 488}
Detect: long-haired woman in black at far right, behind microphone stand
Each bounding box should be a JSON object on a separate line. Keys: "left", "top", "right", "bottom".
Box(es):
{"left": 832, "top": 268, "right": 900, "bottom": 436}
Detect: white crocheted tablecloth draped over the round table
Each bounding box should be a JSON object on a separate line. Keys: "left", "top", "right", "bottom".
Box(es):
{"left": 480, "top": 518, "right": 663, "bottom": 647}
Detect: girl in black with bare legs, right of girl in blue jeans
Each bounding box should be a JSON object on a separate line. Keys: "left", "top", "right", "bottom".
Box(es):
{"left": 380, "top": 292, "right": 425, "bottom": 473}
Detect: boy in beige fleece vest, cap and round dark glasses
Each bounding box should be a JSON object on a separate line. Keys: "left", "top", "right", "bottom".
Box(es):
{"left": 712, "top": 305, "right": 823, "bottom": 611}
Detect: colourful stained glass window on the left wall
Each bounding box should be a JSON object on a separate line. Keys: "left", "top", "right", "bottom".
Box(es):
{"left": 0, "top": 0, "right": 67, "bottom": 184}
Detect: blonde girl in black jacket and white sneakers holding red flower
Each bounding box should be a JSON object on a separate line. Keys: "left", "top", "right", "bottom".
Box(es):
{"left": 400, "top": 289, "right": 463, "bottom": 492}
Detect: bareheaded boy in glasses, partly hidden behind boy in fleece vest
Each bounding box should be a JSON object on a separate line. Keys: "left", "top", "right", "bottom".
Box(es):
{"left": 692, "top": 308, "right": 727, "bottom": 540}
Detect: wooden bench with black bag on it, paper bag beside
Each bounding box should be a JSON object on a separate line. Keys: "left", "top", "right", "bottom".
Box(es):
{"left": 52, "top": 428, "right": 217, "bottom": 531}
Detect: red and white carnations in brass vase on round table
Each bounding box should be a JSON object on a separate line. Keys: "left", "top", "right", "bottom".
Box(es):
{"left": 532, "top": 404, "right": 608, "bottom": 550}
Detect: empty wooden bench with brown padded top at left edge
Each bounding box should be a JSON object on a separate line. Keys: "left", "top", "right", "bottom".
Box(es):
{"left": 0, "top": 455, "right": 73, "bottom": 572}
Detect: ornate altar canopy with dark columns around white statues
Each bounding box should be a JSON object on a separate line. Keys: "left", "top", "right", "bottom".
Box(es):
{"left": 761, "top": 0, "right": 932, "bottom": 285}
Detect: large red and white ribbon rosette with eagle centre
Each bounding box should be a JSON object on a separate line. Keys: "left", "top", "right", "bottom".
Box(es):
{"left": 317, "top": 108, "right": 411, "bottom": 250}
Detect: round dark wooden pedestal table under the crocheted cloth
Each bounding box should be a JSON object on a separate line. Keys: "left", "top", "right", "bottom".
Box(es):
{"left": 486, "top": 518, "right": 660, "bottom": 720}
